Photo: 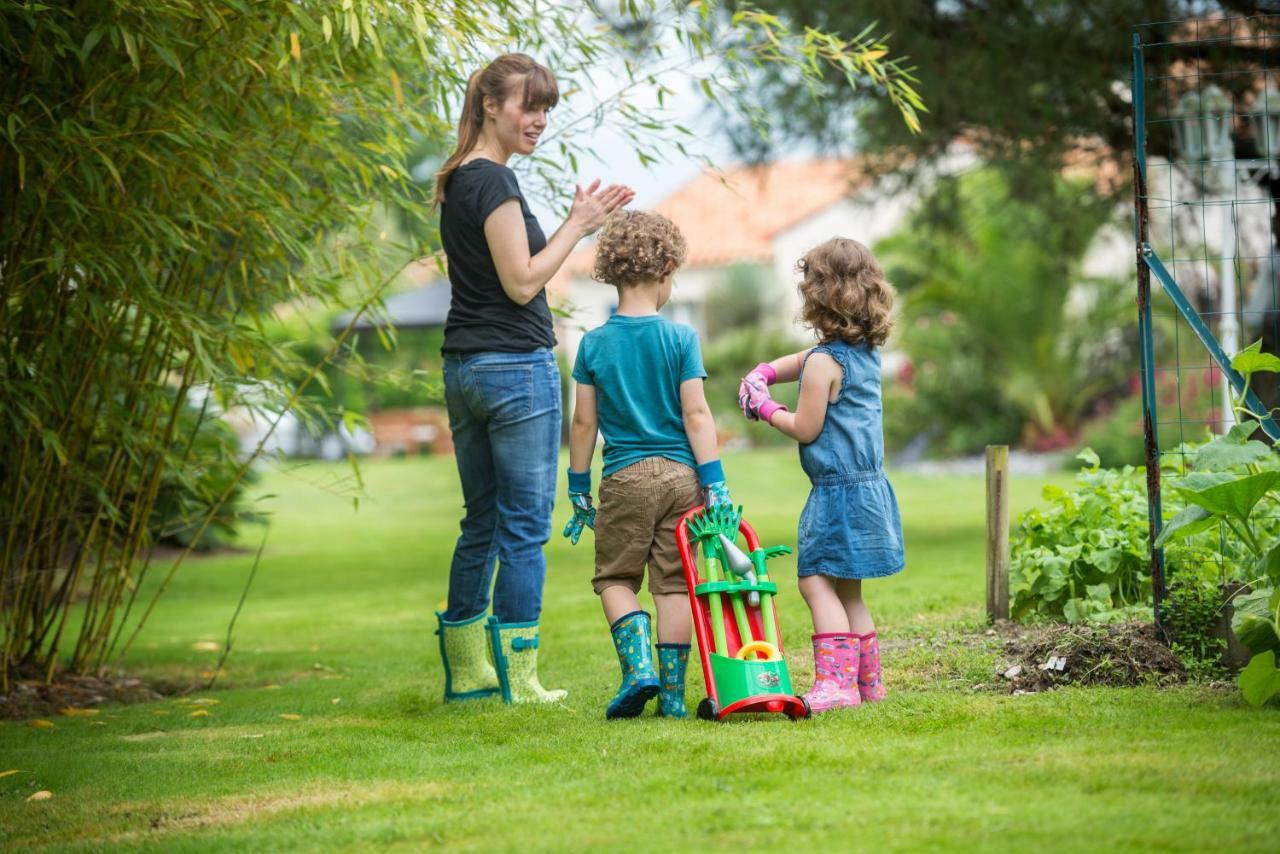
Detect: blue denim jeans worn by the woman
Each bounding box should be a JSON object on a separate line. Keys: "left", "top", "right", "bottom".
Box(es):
{"left": 444, "top": 348, "right": 561, "bottom": 622}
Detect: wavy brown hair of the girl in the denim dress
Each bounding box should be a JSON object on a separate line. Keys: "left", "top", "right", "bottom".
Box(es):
{"left": 796, "top": 237, "right": 893, "bottom": 347}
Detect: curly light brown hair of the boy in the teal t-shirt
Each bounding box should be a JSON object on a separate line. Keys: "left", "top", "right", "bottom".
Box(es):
{"left": 591, "top": 210, "right": 686, "bottom": 288}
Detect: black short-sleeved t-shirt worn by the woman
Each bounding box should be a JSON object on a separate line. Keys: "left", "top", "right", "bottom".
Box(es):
{"left": 440, "top": 159, "right": 556, "bottom": 355}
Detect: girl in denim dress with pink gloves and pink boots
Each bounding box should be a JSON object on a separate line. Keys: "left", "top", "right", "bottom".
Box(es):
{"left": 739, "top": 237, "right": 904, "bottom": 712}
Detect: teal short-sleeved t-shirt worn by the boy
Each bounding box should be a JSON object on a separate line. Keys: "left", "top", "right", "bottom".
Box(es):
{"left": 573, "top": 315, "right": 707, "bottom": 476}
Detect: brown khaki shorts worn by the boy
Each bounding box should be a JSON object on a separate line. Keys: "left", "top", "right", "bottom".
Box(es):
{"left": 591, "top": 457, "right": 703, "bottom": 593}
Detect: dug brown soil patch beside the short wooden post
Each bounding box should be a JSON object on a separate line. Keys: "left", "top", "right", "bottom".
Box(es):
{"left": 998, "top": 622, "right": 1187, "bottom": 693}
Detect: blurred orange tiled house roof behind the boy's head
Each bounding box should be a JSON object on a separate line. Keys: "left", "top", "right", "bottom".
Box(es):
{"left": 564, "top": 157, "right": 868, "bottom": 277}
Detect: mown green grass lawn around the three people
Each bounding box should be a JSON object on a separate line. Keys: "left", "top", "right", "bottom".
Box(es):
{"left": 0, "top": 452, "right": 1280, "bottom": 850}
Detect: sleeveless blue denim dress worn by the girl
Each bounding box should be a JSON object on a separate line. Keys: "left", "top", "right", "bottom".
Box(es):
{"left": 796, "top": 342, "right": 905, "bottom": 579}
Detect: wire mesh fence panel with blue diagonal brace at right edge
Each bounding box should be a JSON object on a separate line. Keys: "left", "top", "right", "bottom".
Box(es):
{"left": 1132, "top": 15, "right": 1280, "bottom": 616}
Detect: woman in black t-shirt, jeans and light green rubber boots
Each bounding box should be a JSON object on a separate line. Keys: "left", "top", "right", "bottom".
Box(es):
{"left": 435, "top": 54, "right": 634, "bottom": 703}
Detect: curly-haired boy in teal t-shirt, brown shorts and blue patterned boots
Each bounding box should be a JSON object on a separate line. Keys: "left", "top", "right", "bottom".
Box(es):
{"left": 564, "top": 210, "right": 730, "bottom": 718}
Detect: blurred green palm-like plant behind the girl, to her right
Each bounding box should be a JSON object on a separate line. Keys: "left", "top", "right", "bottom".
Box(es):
{"left": 877, "top": 169, "right": 1132, "bottom": 443}
